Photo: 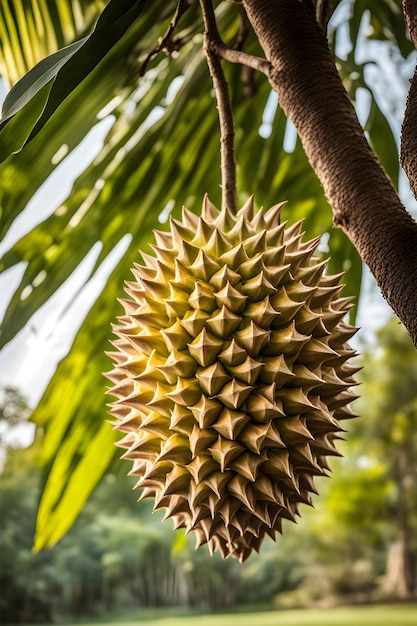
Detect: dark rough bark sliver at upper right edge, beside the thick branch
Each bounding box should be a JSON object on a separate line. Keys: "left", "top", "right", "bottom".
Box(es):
{"left": 401, "top": 0, "right": 417, "bottom": 198}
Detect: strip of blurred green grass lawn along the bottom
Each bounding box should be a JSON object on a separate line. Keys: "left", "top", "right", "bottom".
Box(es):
{"left": 26, "top": 605, "right": 417, "bottom": 626}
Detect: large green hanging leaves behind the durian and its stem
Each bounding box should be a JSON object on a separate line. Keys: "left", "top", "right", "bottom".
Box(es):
{"left": 0, "top": 0, "right": 411, "bottom": 548}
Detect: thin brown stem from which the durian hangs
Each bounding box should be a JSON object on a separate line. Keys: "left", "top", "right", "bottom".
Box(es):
{"left": 200, "top": 0, "right": 238, "bottom": 213}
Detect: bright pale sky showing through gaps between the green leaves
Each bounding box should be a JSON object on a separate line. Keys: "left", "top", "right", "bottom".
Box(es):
{"left": 0, "top": 3, "right": 417, "bottom": 440}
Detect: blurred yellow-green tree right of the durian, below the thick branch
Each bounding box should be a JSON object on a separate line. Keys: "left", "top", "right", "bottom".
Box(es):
{"left": 300, "top": 318, "right": 417, "bottom": 597}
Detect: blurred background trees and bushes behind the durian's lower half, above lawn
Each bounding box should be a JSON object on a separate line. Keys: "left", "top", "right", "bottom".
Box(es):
{"left": 0, "top": 320, "right": 417, "bottom": 623}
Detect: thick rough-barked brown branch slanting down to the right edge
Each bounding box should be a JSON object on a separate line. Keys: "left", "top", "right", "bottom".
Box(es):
{"left": 243, "top": 0, "right": 417, "bottom": 346}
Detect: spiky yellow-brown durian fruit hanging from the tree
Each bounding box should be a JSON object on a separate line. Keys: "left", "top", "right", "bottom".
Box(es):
{"left": 107, "top": 198, "right": 358, "bottom": 561}
